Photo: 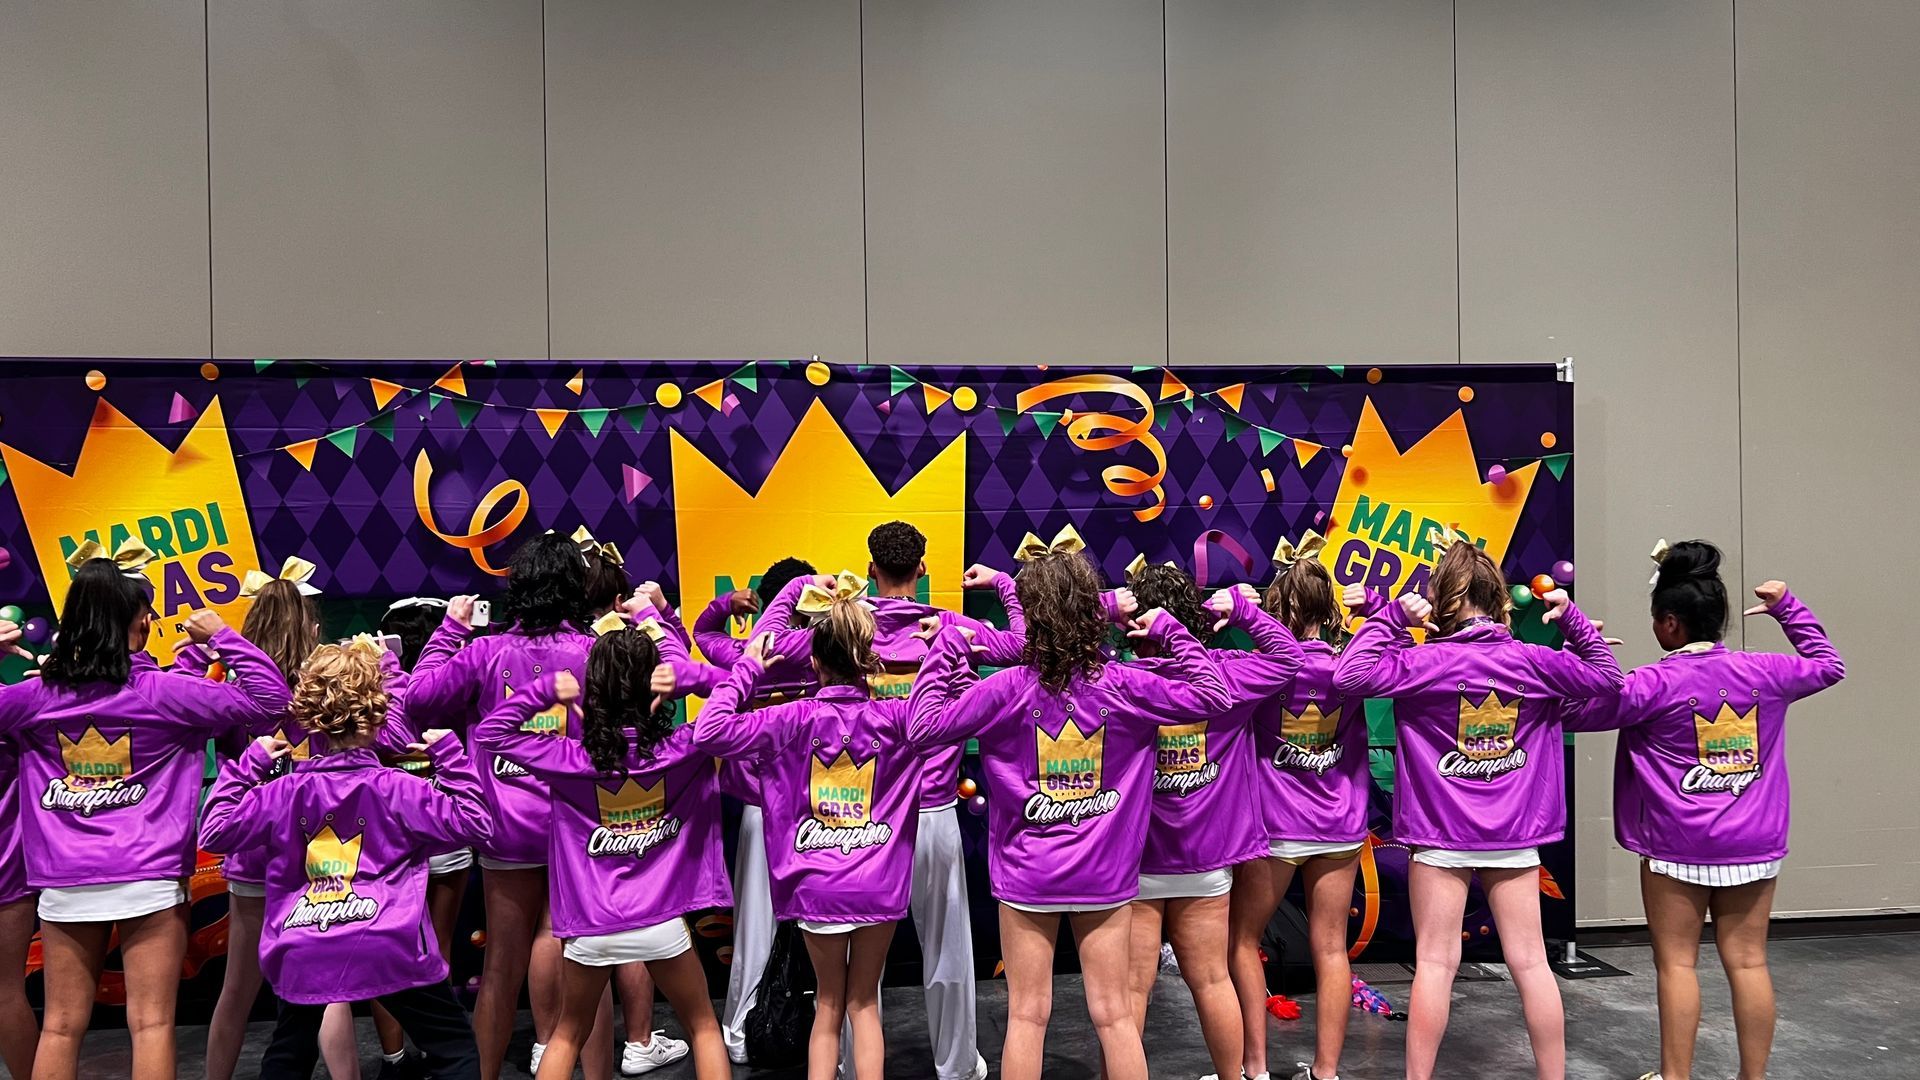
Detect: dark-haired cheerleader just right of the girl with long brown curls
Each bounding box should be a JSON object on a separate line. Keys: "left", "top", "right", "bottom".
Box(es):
{"left": 1127, "top": 565, "right": 1300, "bottom": 1076}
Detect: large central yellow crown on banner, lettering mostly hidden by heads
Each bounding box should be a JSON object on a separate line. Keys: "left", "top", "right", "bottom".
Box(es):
{"left": 670, "top": 400, "right": 966, "bottom": 684}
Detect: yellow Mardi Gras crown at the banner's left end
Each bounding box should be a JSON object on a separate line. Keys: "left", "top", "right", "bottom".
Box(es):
{"left": 0, "top": 398, "right": 259, "bottom": 663}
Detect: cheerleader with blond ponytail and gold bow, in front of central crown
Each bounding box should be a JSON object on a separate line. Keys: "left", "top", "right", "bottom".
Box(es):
{"left": 693, "top": 571, "right": 920, "bottom": 1080}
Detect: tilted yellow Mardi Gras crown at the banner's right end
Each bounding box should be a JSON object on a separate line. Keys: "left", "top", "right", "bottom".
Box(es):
{"left": 1319, "top": 398, "right": 1540, "bottom": 594}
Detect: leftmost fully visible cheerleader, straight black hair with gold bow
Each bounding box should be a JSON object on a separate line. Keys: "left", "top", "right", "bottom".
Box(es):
{"left": 0, "top": 542, "right": 288, "bottom": 1080}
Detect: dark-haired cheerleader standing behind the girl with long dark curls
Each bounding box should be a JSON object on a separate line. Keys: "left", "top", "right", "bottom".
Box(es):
{"left": 407, "top": 532, "right": 612, "bottom": 1080}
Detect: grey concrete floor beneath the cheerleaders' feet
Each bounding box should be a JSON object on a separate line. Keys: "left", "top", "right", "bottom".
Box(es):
{"left": 11, "top": 934, "right": 1920, "bottom": 1080}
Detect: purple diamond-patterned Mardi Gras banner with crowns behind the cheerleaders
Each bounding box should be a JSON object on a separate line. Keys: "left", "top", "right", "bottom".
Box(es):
{"left": 0, "top": 359, "right": 1574, "bottom": 999}
